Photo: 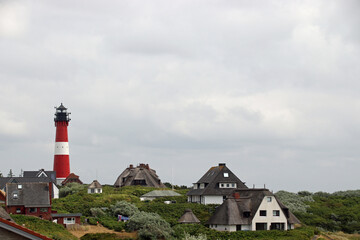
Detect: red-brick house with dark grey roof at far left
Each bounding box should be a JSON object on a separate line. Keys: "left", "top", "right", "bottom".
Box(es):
{"left": 5, "top": 182, "right": 52, "bottom": 220}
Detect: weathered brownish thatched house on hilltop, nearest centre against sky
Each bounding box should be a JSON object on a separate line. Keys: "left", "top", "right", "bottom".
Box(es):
{"left": 114, "top": 163, "right": 166, "bottom": 188}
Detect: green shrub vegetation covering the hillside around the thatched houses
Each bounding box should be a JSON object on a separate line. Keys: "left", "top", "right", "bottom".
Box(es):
{"left": 53, "top": 184, "right": 360, "bottom": 239}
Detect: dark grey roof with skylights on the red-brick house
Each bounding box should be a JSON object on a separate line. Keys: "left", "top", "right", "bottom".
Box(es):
{"left": 6, "top": 182, "right": 50, "bottom": 207}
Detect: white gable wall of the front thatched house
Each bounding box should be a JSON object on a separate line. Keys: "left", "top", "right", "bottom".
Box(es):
{"left": 251, "top": 197, "right": 288, "bottom": 231}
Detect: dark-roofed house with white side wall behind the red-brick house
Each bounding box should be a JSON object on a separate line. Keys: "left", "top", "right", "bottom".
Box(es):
{"left": 0, "top": 172, "right": 59, "bottom": 198}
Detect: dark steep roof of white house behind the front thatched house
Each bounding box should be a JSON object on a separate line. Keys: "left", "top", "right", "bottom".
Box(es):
{"left": 187, "top": 163, "right": 247, "bottom": 196}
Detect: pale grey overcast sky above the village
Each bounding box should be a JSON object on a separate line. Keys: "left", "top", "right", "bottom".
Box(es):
{"left": 0, "top": 0, "right": 360, "bottom": 192}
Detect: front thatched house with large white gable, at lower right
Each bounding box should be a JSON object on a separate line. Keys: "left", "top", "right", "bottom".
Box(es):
{"left": 207, "top": 188, "right": 300, "bottom": 232}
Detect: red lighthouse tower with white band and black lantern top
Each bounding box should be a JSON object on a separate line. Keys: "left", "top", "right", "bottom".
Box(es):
{"left": 54, "top": 103, "right": 71, "bottom": 185}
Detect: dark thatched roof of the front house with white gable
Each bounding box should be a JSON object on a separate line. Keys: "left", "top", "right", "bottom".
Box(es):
{"left": 207, "top": 189, "right": 300, "bottom": 225}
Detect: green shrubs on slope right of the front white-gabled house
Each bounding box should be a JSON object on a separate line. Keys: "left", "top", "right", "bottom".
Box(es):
{"left": 276, "top": 190, "right": 360, "bottom": 233}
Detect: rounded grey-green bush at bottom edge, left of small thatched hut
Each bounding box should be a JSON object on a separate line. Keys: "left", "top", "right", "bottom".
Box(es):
{"left": 127, "top": 212, "right": 173, "bottom": 239}
